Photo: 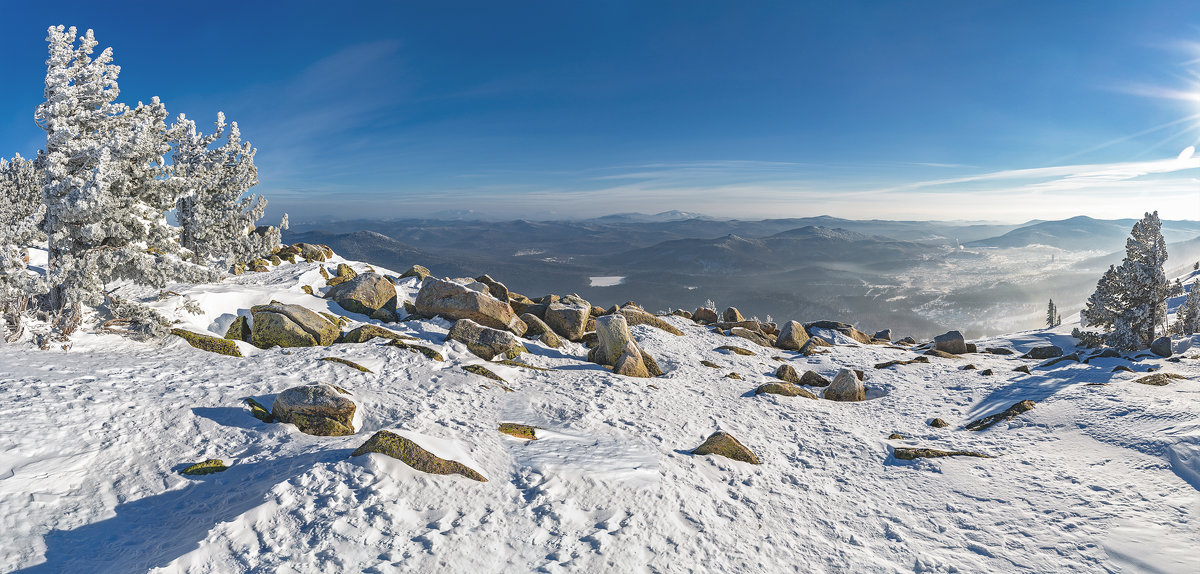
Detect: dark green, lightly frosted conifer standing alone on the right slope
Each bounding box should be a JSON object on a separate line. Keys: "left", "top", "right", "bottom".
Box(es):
{"left": 1080, "top": 211, "right": 1172, "bottom": 349}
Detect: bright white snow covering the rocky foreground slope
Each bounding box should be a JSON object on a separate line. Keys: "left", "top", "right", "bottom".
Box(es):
{"left": 0, "top": 253, "right": 1200, "bottom": 573}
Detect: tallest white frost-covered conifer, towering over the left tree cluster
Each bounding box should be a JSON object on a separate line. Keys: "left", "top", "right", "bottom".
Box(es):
{"left": 35, "top": 26, "right": 212, "bottom": 310}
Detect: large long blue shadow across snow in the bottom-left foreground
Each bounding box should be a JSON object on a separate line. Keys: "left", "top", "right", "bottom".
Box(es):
{"left": 18, "top": 449, "right": 349, "bottom": 574}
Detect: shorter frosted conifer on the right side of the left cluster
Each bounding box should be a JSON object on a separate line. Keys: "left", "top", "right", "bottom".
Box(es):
{"left": 172, "top": 113, "right": 287, "bottom": 268}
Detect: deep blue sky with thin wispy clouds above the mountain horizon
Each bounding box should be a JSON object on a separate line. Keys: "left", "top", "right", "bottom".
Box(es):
{"left": 0, "top": 0, "right": 1200, "bottom": 221}
